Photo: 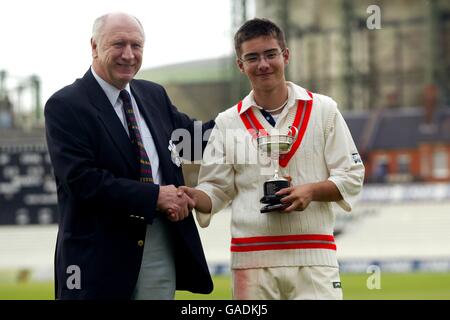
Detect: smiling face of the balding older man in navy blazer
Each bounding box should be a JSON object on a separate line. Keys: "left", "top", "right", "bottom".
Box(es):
{"left": 91, "top": 16, "right": 144, "bottom": 90}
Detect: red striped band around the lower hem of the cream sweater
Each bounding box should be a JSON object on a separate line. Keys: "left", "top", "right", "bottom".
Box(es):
{"left": 230, "top": 234, "right": 336, "bottom": 252}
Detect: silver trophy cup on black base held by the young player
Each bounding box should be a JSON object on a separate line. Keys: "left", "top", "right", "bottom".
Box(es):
{"left": 256, "top": 126, "right": 298, "bottom": 213}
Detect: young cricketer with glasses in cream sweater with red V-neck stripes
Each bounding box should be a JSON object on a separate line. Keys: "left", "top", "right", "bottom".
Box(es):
{"left": 183, "top": 19, "right": 364, "bottom": 299}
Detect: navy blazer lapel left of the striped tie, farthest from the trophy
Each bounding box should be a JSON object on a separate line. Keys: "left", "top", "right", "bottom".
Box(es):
{"left": 83, "top": 70, "right": 139, "bottom": 172}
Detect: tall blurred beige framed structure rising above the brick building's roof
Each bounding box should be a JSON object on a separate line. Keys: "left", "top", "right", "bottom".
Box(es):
{"left": 251, "top": 0, "right": 450, "bottom": 110}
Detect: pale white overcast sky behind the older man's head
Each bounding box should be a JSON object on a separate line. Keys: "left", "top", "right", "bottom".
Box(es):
{"left": 0, "top": 0, "right": 236, "bottom": 112}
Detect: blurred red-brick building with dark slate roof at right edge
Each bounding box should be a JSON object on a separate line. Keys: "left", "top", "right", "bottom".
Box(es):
{"left": 345, "top": 107, "right": 450, "bottom": 183}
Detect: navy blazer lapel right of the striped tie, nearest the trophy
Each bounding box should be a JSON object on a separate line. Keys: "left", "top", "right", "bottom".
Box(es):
{"left": 130, "top": 83, "right": 181, "bottom": 183}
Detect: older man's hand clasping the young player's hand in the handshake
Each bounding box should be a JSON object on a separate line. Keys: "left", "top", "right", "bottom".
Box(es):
{"left": 157, "top": 185, "right": 195, "bottom": 222}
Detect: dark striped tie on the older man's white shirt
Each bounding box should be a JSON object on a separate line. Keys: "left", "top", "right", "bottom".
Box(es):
{"left": 119, "top": 90, "right": 153, "bottom": 182}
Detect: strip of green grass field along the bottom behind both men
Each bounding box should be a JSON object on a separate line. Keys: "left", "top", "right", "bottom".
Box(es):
{"left": 0, "top": 273, "right": 450, "bottom": 300}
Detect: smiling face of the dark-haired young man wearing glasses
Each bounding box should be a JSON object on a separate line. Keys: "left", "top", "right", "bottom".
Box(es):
{"left": 237, "top": 36, "right": 289, "bottom": 91}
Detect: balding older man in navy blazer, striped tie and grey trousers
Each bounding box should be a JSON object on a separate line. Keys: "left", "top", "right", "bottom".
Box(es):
{"left": 45, "top": 13, "right": 214, "bottom": 299}
